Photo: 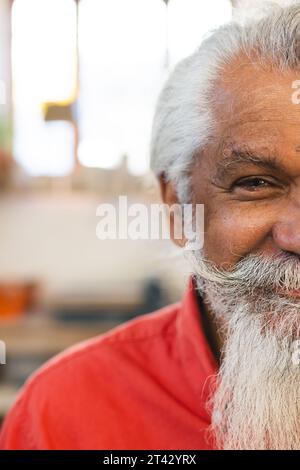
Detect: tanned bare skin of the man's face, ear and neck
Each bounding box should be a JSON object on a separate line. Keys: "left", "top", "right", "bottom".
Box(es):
{"left": 160, "top": 57, "right": 300, "bottom": 356}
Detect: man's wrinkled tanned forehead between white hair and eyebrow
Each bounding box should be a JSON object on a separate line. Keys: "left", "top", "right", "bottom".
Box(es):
{"left": 211, "top": 57, "right": 300, "bottom": 153}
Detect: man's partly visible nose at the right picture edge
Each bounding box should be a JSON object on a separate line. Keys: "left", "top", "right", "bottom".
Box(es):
{"left": 273, "top": 207, "right": 300, "bottom": 255}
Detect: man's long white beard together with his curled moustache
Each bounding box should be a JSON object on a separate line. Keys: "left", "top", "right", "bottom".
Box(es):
{"left": 188, "top": 252, "right": 300, "bottom": 449}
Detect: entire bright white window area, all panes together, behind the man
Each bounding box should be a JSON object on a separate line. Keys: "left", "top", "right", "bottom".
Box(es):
{"left": 12, "top": 0, "right": 231, "bottom": 176}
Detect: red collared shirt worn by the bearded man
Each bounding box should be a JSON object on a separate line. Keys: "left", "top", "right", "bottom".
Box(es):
{"left": 0, "top": 280, "right": 217, "bottom": 450}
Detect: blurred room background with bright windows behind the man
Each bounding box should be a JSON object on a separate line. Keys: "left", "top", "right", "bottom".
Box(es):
{"left": 0, "top": 0, "right": 234, "bottom": 421}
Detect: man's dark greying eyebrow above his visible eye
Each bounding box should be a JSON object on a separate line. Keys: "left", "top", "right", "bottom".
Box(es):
{"left": 215, "top": 149, "right": 284, "bottom": 180}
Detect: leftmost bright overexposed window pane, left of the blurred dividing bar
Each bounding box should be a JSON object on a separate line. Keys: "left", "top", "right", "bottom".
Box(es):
{"left": 12, "top": 0, "right": 76, "bottom": 176}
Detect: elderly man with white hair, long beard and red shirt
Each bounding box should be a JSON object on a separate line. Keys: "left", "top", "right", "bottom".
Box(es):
{"left": 0, "top": 4, "right": 300, "bottom": 449}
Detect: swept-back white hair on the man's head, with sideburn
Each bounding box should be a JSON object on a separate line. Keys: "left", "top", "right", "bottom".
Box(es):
{"left": 150, "top": 0, "right": 300, "bottom": 203}
